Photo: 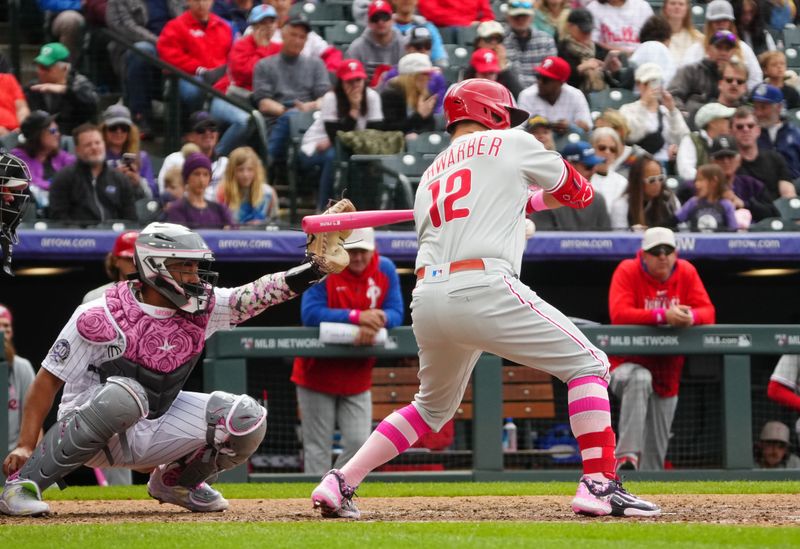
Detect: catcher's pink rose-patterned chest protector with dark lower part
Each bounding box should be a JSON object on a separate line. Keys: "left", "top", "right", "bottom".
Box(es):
{"left": 77, "top": 282, "right": 214, "bottom": 419}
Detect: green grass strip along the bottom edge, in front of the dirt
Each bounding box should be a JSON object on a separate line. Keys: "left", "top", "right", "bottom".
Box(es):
{"left": 0, "top": 522, "right": 800, "bottom": 549}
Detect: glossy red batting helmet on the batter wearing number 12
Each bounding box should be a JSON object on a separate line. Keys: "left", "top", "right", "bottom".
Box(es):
{"left": 444, "top": 78, "right": 528, "bottom": 131}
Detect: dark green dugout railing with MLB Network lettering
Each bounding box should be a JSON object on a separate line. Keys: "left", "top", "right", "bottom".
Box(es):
{"left": 0, "top": 324, "right": 800, "bottom": 482}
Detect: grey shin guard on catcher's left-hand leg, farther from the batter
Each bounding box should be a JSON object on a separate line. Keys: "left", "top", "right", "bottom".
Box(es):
{"left": 19, "top": 377, "right": 147, "bottom": 490}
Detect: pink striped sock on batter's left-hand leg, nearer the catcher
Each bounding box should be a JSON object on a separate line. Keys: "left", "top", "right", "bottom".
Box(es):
{"left": 341, "top": 404, "right": 431, "bottom": 487}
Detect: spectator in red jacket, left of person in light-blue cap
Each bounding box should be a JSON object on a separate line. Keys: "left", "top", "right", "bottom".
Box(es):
{"left": 156, "top": 0, "right": 233, "bottom": 119}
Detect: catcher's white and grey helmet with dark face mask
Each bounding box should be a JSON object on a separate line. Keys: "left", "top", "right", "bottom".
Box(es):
{"left": 134, "top": 223, "right": 219, "bottom": 314}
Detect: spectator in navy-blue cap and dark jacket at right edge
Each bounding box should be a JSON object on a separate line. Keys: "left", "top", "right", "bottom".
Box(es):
{"left": 750, "top": 84, "right": 800, "bottom": 179}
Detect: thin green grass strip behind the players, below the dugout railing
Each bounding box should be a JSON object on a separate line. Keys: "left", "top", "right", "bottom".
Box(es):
{"left": 45, "top": 481, "right": 800, "bottom": 500}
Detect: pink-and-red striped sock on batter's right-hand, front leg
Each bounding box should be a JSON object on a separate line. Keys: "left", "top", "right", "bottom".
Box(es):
{"left": 567, "top": 376, "right": 617, "bottom": 481}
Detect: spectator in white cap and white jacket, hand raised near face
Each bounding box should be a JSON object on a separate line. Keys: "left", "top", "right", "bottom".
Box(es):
{"left": 619, "top": 63, "right": 689, "bottom": 162}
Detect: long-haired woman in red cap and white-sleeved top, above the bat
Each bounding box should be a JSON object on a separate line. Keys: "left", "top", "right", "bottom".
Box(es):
{"left": 300, "top": 59, "right": 384, "bottom": 211}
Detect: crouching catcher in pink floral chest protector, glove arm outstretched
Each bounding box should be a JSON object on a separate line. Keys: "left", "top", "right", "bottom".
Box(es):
{"left": 0, "top": 201, "right": 355, "bottom": 516}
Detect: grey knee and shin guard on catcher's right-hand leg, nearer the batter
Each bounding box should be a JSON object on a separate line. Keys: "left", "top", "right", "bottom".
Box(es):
{"left": 173, "top": 391, "right": 267, "bottom": 487}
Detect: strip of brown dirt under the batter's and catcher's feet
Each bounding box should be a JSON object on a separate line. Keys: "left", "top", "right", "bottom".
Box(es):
{"left": 0, "top": 494, "right": 800, "bottom": 526}
